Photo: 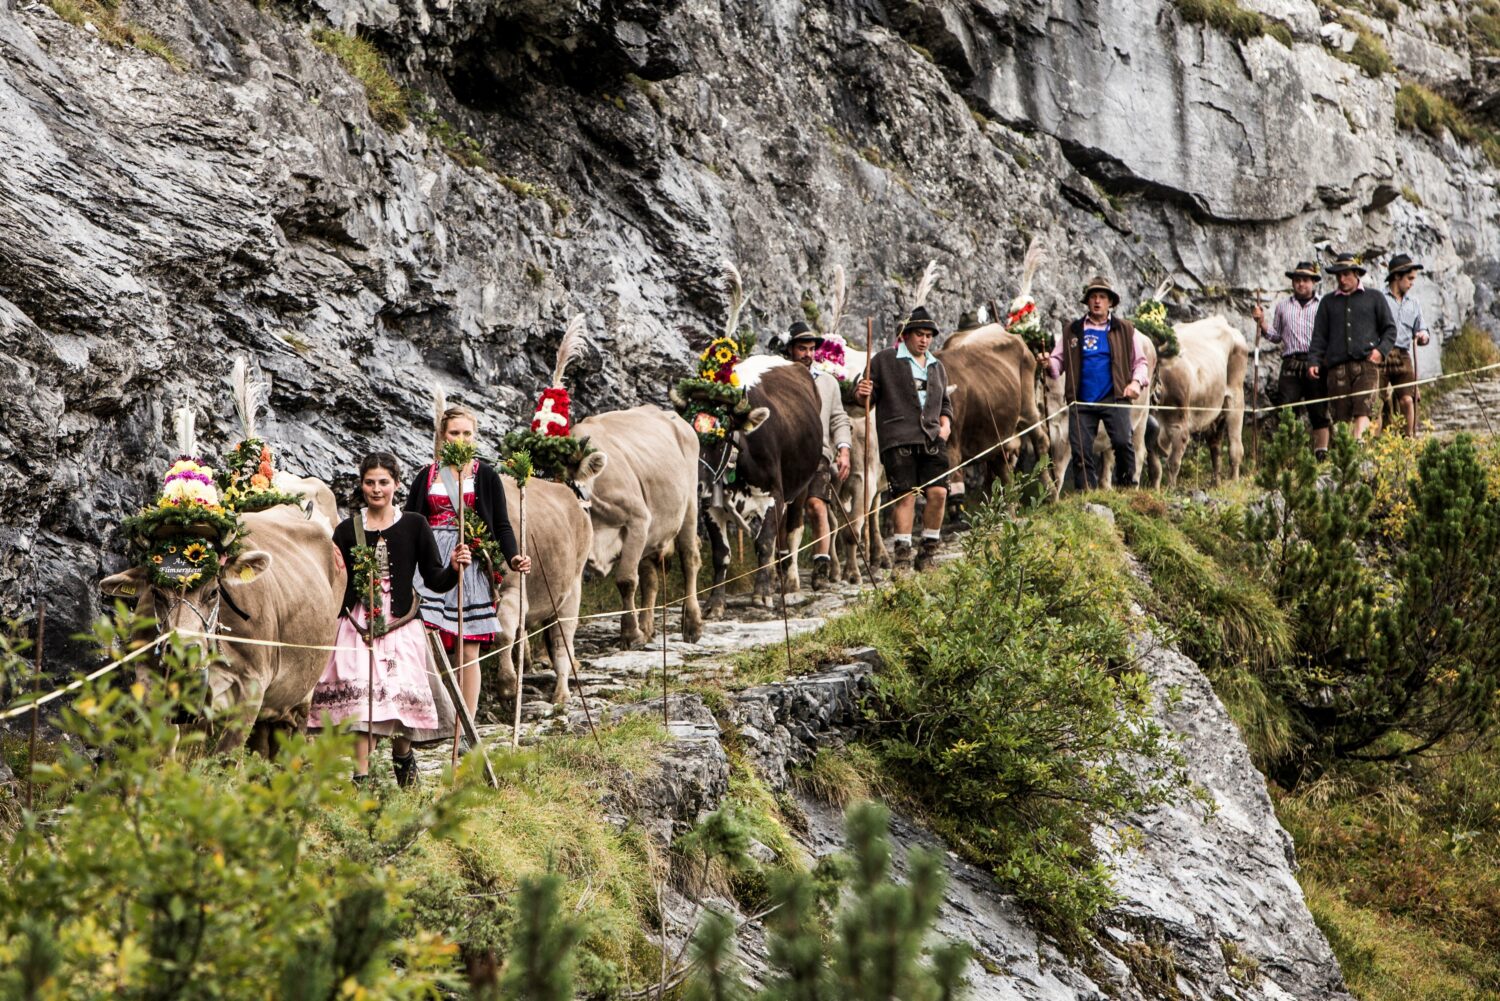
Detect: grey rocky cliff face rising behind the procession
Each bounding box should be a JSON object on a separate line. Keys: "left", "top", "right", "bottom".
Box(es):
{"left": 0, "top": 0, "right": 1500, "bottom": 635}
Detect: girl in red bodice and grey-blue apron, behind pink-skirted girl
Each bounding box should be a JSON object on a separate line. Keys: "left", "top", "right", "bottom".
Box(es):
{"left": 407, "top": 407, "right": 531, "bottom": 716}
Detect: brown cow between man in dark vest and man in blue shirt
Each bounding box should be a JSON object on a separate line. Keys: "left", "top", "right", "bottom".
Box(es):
{"left": 938, "top": 323, "right": 1050, "bottom": 500}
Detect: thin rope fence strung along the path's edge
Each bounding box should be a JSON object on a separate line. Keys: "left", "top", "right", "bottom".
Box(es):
{"left": 0, "top": 355, "right": 1500, "bottom": 720}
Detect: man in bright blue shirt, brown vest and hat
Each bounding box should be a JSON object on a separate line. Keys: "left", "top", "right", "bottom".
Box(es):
{"left": 1043, "top": 278, "right": 1146, "bottom": 491}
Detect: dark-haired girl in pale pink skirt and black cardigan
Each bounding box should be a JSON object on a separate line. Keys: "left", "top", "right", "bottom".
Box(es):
{"left": 312, "top": 452, "right": 470, "bottom": 786}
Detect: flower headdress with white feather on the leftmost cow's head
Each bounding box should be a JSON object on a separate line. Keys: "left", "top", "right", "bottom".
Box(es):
{"left": 120, "top": 407, "right": 245, "bottom": 591}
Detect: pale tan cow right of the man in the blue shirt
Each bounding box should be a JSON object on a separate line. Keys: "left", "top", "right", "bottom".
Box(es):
{"left": 1152, "top": 317, "right": 1250, "bottom": 486}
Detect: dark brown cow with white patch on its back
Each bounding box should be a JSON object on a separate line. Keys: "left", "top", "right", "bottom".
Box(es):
{"left": 699, "top": 356, "right": 824, "bottom": 617}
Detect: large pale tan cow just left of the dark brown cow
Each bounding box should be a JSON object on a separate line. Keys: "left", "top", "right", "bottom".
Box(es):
{"left": 573, "top": 407, "right": 704, "bottom": 647}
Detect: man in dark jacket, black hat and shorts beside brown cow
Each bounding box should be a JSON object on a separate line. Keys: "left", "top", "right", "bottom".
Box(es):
{"left": 855, "top": 306, "right": 953, "bottom": 570}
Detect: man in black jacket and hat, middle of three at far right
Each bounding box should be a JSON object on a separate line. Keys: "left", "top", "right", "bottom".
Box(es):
{"left": 1308, "top": 254, "right": 1397, "bottom": 438}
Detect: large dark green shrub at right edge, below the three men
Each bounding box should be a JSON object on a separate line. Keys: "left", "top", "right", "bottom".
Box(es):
{"left": 1247, "top": 422, "right": 1500, "bottom": 785}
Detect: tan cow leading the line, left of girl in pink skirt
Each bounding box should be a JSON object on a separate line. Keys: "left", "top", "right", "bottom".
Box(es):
{"left": 99, "top": 504, "right": 345, "bottom": 752}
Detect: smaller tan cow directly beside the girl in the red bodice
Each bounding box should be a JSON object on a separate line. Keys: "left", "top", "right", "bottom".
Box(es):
{"left": 495, "top": 477, "right": 594, "bottom": 705}
